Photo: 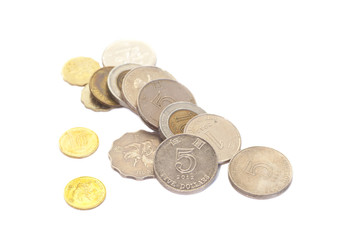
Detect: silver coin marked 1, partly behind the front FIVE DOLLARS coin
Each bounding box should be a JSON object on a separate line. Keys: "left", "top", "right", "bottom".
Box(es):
{"left": 184, "top": 114, "right": 241, "bottom": 163}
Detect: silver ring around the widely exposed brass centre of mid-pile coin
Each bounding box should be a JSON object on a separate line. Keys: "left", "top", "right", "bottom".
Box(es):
{"left": 159, "top": 101, "right": 205, "bottom": 139}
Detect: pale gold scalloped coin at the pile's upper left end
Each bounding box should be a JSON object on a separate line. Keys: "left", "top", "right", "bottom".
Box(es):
{"left": 61, "top": 57, "right": 100, "bottom": 86}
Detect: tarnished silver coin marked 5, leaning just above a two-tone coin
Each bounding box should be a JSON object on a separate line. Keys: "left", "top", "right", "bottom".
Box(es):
{"left": 137, "top": 79, "right": 196, "bottom": 129}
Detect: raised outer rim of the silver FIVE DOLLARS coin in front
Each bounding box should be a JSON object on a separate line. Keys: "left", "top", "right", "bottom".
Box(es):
{"left": 154, "top": 133, "right": 219, "bottom": 195}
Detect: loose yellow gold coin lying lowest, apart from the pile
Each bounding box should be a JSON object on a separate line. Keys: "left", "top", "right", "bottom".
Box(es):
{"left": 64, "top": 177, "right": 106, "bottom": 210}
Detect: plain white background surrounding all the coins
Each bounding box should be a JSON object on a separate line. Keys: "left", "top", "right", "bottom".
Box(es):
{"left": 0, "top": 0, "right": 360, "bottom": 239}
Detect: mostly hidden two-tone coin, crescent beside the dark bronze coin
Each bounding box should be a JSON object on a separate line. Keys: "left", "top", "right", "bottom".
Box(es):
{"left": 107, "top": 63, "right": 140, "bottom": 107}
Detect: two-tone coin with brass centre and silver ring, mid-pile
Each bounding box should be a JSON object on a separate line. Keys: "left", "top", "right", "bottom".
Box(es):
{"left": 159, "top": 102, "right": 205, "bottom": 139}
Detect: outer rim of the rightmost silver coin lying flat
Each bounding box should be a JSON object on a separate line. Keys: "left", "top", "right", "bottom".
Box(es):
{"left": 228, "top": 146, "right": 293, "bottom": 199}
